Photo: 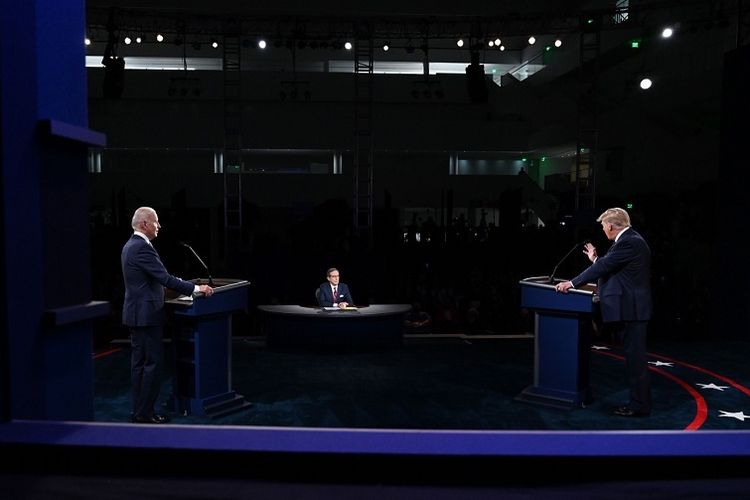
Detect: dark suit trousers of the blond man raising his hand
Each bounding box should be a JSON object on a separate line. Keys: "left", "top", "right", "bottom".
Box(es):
{"left": 618, "top": 321, "right": 651, "bottom": 413}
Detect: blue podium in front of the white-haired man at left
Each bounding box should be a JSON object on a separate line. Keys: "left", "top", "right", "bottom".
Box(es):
{"left": 167, "top": 279, "right": 251, "bottom": 417}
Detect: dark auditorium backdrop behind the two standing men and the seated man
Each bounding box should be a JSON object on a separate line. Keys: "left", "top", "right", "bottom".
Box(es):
{"left": 81, "top": 2, "right": 745, "bottom": 342}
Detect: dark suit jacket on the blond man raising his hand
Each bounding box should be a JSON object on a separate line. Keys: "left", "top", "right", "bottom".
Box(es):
{"left": 570, "top": 228, "right": 652, "bottom": 323}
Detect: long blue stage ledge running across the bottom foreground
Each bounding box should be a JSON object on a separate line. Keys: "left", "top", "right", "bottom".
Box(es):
{"left": 0, "top": 420, "right": 750, "bottom": 457}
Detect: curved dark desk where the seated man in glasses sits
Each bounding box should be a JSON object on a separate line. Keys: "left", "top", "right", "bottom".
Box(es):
{"left": 258, "top": 304, "right": 411, "bottom": 347}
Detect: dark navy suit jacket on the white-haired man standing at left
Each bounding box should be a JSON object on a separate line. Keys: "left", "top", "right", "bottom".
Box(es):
{"left": 120, "top": 234, "right": 195, "bottom": 326}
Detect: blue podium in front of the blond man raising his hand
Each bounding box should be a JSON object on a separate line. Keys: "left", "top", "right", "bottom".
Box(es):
{"left": 516, "top": 276, "right": 596, "bottom": 409}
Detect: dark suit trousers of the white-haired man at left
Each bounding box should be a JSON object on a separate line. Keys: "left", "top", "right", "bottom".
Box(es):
{"left": 130, "top": 325, "right": 164, "bottom": 418}
